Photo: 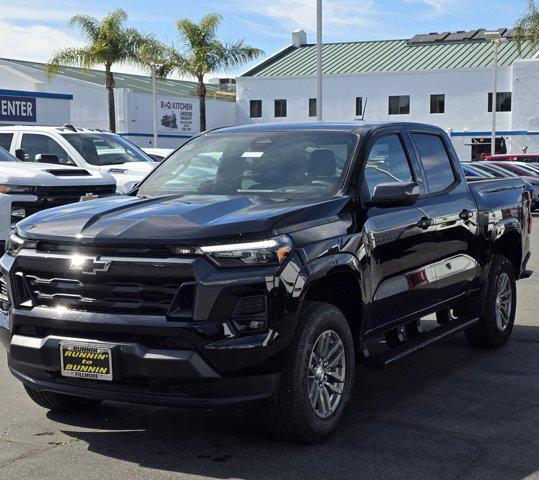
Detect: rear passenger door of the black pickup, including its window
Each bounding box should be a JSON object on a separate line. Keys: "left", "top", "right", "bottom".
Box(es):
{"left": 410, "top": 130, "right": 478, "bottom": 302}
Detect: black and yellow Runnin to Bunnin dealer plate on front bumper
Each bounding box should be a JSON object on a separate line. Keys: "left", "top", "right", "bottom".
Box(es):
{"left": 60, "top": 342, "right": 112, "bottom": 382}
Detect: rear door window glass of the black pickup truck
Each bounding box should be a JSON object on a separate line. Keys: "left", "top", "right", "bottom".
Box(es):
{"left": 412, "top": 133, "right": 456, "bottom": 193}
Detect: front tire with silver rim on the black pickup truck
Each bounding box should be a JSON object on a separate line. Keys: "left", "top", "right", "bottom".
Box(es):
{"left": 265, "top": 302, "right": 355, "bottom": 443}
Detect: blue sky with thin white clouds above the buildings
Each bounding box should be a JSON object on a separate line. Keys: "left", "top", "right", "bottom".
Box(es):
{"left": 0, "top": 0, "right": 527, "bottom": 75}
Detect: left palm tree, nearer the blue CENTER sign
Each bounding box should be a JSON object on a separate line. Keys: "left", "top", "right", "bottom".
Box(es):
{"left": 46, "top": 8, "right": 142, "bottom": 132}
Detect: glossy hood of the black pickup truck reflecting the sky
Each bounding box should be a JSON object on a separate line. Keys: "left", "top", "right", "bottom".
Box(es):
{"left": 18, "top": 195, "right": 349, "bottom": 245}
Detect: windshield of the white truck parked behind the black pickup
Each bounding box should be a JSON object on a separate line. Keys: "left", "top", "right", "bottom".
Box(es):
{"left": 62, "top": 133, "right": 152, "bottom": 166}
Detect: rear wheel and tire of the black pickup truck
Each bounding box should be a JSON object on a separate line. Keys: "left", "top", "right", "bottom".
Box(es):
{"left": 465, "top": 255, "right": 517, "bottom": 348}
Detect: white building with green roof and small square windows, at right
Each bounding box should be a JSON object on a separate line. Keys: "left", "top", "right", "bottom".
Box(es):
{"left": 237, "top": 29, "right": 539, "bottom": 159}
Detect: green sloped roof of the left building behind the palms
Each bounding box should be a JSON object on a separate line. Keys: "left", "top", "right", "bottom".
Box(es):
{"left": 0, "top": 58, "right": 236, "bottom": 101}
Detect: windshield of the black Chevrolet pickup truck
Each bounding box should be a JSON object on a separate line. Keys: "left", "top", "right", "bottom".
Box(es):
{"left": 138, "top": 131, "right": 358, "bottom": 197}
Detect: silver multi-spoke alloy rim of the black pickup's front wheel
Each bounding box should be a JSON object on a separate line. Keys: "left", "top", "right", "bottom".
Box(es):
{"left": 308, "top": 330, "right": 346, "bottom": 418}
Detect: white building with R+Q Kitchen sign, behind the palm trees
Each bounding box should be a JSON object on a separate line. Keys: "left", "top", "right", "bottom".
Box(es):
{"left": 0, "top": 59, "right": 236, "bottom": 148}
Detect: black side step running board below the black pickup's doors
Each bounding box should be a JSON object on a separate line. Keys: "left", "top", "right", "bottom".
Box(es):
{"left": 365, "top": 318, "right": 479, "bottom": 368}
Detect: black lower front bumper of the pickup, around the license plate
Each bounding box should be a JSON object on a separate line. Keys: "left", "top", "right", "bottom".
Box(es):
{"left": 9, "top": 335, "right": 279, "bottom": 408}
